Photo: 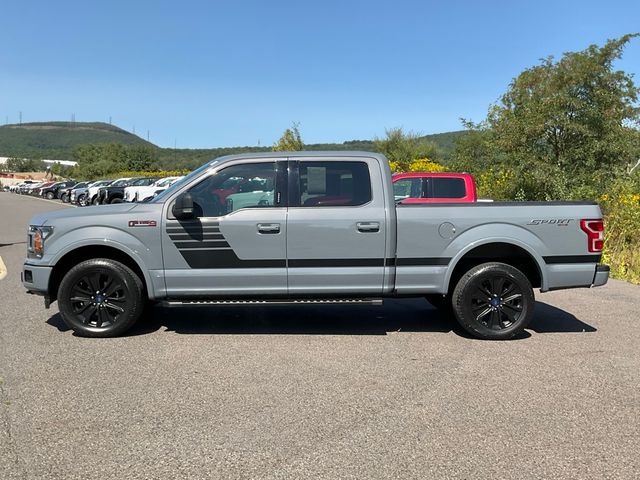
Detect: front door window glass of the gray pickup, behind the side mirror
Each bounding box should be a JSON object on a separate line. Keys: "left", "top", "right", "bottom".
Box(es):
{"left": 189, "top": 162, "right": 276, "bottom": 217}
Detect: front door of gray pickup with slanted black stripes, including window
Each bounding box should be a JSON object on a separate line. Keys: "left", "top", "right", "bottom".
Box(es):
{"left": 162, "top": 159, "right": 287, "bottom": 297}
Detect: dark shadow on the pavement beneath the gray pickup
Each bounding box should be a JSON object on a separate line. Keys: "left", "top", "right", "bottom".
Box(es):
{"left": 47, "top": 299, "right": 596, "bottom": 340}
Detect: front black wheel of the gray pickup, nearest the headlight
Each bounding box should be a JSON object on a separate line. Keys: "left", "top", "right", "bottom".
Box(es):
{"left": 58, "top": 258, "right": 145, "bottom": 337}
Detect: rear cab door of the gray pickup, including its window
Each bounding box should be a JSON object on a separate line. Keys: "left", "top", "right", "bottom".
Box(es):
{"left": 287, "top": 157, "right": 388, "bottom": 295}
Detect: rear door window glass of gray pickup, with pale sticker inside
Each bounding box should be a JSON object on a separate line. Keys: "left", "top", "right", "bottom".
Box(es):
{"left": 298, "top": 162, "right": 371, "bottom": 207}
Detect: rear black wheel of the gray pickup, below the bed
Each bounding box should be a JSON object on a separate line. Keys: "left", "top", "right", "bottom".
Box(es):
{"left": 452, "top": 262, "right": 535, "bottom": 340}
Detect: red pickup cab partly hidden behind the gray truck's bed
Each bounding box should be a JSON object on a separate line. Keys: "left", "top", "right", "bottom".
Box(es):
{"left": 392, "top": 172, "right": 477, "bottom": 204}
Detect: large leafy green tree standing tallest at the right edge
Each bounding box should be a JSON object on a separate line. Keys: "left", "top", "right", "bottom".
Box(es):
{"left": 454, "top": 34, "right": 640, "bottom": 199}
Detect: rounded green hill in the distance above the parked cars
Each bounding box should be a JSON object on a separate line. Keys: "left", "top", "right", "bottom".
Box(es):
{"left": 0, "top": 122, "right": 153, "bottom": 160}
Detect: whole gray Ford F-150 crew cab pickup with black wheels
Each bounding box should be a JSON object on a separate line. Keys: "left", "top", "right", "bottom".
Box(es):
{"left": 22, "top": 152, "right": 609, "bottom": 339}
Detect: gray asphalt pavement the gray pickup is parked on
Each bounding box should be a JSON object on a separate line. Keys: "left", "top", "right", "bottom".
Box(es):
{"left": 0, "top": 189, "right": 640, "bottom": 480}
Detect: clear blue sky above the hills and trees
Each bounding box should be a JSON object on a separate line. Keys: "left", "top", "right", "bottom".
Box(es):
{"left": 0, "top": 0, "right": 640, "bottom": 148}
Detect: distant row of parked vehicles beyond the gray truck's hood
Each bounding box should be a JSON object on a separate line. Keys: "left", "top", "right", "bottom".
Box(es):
{"left": 8, "top": 177, "right": 182, "bottom": 207}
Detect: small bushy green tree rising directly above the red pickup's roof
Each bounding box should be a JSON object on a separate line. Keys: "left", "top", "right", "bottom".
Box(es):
{"left": 374, "top": 127, "right": 440, "bottom": 172}
